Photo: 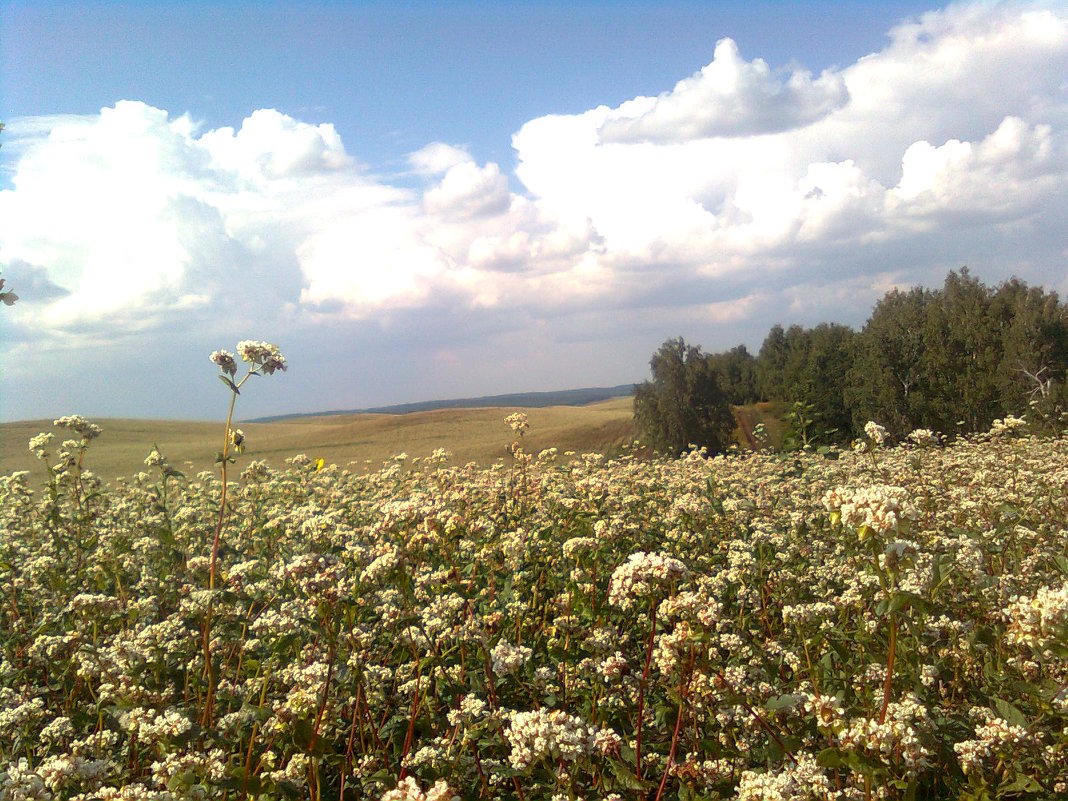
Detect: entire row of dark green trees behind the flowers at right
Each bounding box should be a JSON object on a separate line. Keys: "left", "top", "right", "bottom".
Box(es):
{"left": 634, "top": 268, "right": 1068, "bottom": 453}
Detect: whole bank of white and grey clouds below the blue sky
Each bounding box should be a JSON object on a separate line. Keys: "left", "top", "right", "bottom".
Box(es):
{"left": 0, "top": 3, "right": 1068, "bottom": 427}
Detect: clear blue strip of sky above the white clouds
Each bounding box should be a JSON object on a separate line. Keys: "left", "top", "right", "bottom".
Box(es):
{"left": 0, "top": 0, "right": 929, "bottom": 170}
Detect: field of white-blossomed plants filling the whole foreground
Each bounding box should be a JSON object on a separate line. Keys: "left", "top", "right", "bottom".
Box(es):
{"left": 0, "top": 418, "right": 1068, "bottom": 801}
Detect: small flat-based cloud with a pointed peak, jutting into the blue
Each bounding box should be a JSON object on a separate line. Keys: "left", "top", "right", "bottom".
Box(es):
{"left": 598, "top": 38, "right": 849, "bottom": 143}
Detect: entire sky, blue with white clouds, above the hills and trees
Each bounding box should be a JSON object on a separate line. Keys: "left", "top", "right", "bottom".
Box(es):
{"left": 0, "top": 0, "right": 1068, "bottom": 421}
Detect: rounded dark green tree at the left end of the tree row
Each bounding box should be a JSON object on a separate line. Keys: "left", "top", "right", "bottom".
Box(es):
{"left": 634, "top": 337, "right": 735, "bottom": 455}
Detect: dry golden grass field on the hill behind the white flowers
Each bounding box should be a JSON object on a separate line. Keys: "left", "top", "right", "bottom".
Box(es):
{"left": 0, "top": 397, "right": 634, "bottom": 480}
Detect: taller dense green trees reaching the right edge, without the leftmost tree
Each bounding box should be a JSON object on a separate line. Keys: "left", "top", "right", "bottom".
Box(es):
{"left": 755, "top": 268, "right": 1068, "bottom": 440}
